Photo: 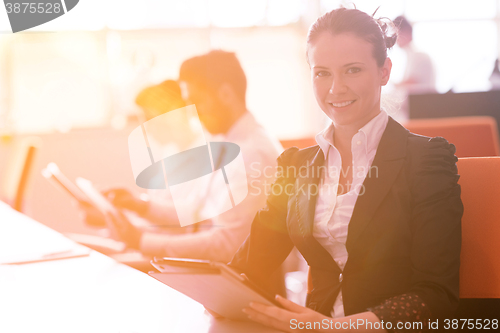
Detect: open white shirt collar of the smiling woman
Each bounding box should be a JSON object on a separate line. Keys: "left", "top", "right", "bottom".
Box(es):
{"left": 316, "top": 109, "right": 389, "bottom": 157}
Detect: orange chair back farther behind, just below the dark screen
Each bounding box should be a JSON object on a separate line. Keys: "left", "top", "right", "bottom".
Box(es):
{"left": 403, "top": 116, "right": 500, "bottom": 157}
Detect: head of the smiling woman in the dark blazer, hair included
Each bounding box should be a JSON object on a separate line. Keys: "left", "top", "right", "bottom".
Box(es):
{"left": 307, "top": 10, "right": 396, "bottom": 128}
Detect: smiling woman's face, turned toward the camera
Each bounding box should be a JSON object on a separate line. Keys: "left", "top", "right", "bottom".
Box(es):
{"left": 308, "top": 32, "right": 392, "bottom": 129}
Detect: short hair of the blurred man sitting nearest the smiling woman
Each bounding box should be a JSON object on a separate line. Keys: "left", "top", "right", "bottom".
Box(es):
{"left": 179, "top": 50, "right": 247, "bottom": 102}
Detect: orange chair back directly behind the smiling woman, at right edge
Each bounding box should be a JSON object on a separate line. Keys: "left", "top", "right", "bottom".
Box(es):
{"left": 457, "top": 157, "right": 500, "bottom": 298}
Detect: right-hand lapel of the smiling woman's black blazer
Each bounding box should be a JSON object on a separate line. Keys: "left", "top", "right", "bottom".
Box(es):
{"left": 346, "top": 117, "right": 408, "bottom": 252}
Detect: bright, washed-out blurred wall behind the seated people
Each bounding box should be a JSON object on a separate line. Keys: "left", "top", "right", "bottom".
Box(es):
{"left": 0, "top": 0, "right": 500, "bottom": 233}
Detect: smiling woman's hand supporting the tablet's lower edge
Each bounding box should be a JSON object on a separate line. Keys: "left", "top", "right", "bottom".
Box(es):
{"left": 243, "top": 295, "right": 331, "bottom": 332}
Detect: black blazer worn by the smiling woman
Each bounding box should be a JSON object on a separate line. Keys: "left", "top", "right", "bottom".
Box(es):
{"left": 230, "top": 118, "right": 463, "bottom": 318}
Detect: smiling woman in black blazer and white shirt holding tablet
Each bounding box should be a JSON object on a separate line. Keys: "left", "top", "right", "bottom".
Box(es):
{"left": 230, "top": 8, "right": 463, "bottom": 332}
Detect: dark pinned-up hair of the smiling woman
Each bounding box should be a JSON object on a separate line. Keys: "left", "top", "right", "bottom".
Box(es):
{"left": 307, "top": 7, "right": 397, "bottom": 67}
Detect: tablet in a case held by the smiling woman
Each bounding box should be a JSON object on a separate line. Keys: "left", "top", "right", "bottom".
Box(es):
{"left": 149, "top": 258, "right": 281, "bottom": 320}
